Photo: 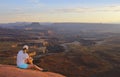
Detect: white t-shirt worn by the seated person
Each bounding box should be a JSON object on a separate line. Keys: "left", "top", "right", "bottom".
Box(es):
{"left": 17, "top": 50, "right": 29, "bottom": 66}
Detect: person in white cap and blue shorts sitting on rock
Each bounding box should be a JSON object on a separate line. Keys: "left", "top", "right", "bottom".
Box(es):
{"left": 17, "top": 45, "right": 47, "bottom": 72}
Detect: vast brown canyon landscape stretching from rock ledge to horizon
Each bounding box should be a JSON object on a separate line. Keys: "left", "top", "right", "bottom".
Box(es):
{"left": 0, "top": 22, "right": 120, "bottom": 77}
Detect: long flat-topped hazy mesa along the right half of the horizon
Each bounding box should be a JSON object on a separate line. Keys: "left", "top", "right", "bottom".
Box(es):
{"left": 52, "top": 23, "right": 120, "bottom": 33}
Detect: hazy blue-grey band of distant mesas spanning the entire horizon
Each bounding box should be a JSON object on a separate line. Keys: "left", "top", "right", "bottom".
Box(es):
{"left": 0, "top": 22, "right": 120, "bottom": 33}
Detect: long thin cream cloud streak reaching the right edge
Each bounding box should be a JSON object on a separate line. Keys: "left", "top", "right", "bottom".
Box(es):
{"left": 53, "top": 6, "right": 120, "bottom": 13}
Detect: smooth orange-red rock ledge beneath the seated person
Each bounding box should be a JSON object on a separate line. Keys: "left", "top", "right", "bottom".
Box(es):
{"left": 0, "top": 65, "right": 65, "bottom": 77}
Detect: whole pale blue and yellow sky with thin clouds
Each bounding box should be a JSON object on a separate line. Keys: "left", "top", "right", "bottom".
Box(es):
{"left": 0, "top": 0, "right": 120, "bottom": 23}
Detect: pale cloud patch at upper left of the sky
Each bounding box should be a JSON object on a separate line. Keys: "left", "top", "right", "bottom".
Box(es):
{"left": 2, "top": 0, "right": 43, "bottom": 16}
